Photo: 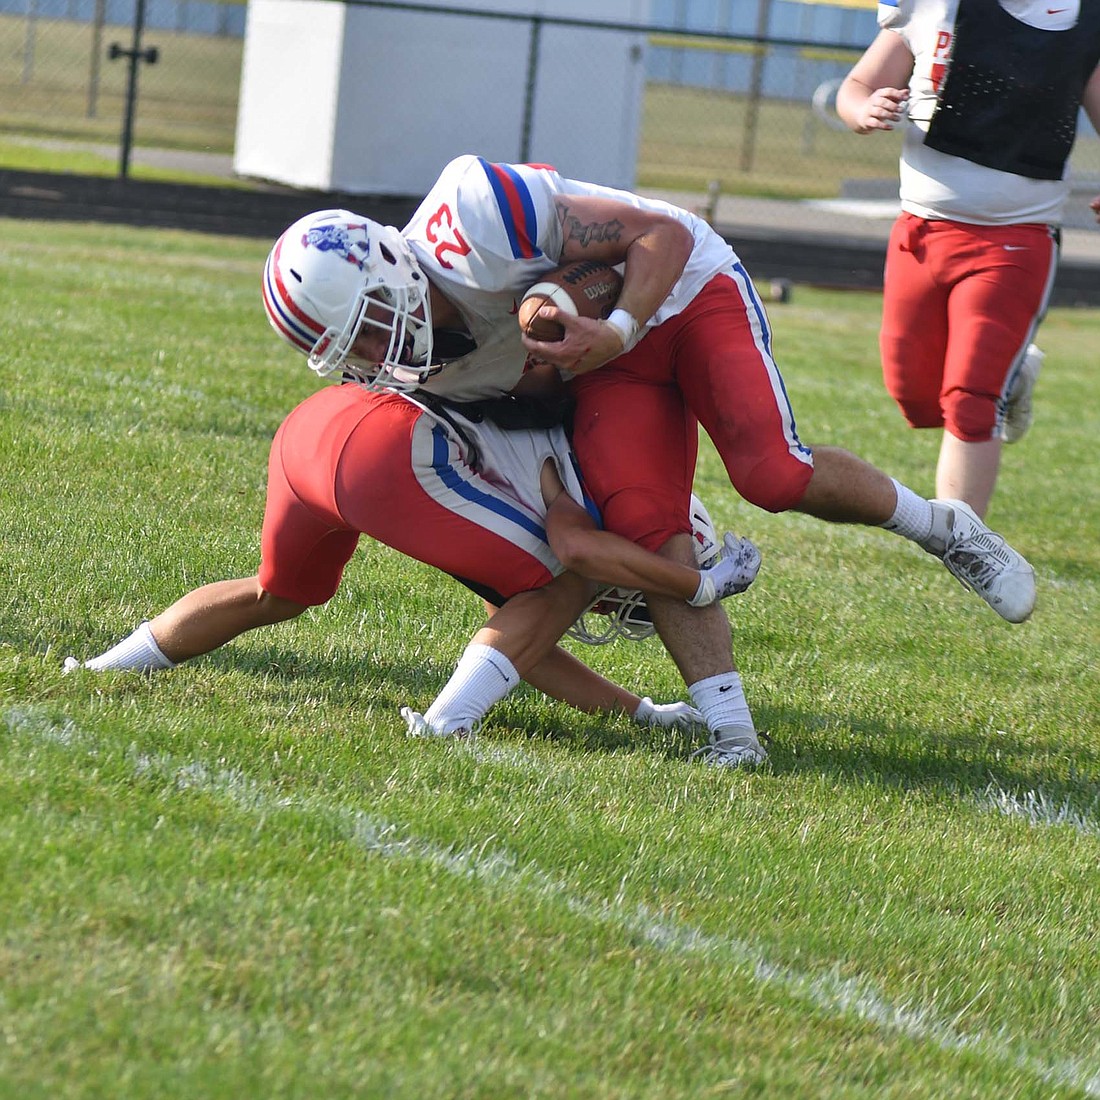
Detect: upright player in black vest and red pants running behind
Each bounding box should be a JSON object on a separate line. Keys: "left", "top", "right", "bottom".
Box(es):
{"left": 836, "top": 0, "right": 1100, "bottom": 516}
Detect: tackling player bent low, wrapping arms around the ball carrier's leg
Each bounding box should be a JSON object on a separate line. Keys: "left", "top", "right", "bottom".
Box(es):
{"left": 66, "top": 384, "right": 760, "bottom": 752}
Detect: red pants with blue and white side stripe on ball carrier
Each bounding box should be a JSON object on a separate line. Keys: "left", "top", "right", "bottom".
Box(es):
{"left": 572, "top": 271, "right": 813, "bottom": 550}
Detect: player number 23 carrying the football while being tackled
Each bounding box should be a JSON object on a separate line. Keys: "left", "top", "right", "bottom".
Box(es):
{"left": 257, "top": 178, "right": 1035, "bottom": 766}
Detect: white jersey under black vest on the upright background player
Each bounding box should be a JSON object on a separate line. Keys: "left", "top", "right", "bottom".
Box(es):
{"left": 878, "top": 0, "right": 1079, "bottom": 226}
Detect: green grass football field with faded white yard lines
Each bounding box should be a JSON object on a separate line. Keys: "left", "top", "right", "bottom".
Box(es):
{"left": 0, "top": 221, "right": 1100, "bottom": 1100}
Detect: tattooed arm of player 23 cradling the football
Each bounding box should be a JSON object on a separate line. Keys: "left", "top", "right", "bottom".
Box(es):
{"left": 524, "top": 195, "right": 694, "bottom": 375}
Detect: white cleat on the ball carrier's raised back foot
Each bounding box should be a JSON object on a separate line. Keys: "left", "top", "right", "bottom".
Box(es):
{"left": 932, "top": 501, "right": 1035, "bottom": 623}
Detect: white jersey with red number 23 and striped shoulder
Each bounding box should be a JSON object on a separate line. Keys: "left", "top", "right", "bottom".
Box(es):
{"left": 402, "top": 155, "right": 737, "bottom": 400}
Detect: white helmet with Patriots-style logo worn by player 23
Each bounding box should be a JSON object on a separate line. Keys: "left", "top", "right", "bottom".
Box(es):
{"left": 263, "top": 210, "right": 432, "bottom": 391}
